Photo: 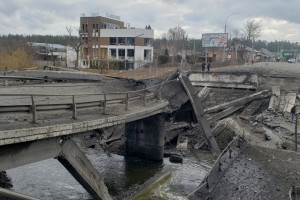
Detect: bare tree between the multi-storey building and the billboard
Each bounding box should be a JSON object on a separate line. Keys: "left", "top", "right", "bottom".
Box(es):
{"left": 163, "top": 25, "right": 187, "bottom": 65}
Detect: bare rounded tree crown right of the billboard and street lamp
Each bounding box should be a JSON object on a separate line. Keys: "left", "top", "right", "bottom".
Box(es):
{"left": 242, "top": 19, "right": 262, "bottom": 41}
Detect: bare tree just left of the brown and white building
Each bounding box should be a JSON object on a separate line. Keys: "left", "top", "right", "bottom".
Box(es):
{"left": 66, "top": 26, "right": 86, "bottom": 69}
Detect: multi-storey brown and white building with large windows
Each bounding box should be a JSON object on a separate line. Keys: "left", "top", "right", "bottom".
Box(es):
{"left": 79, "top": 15, "right": 154, "bottom": 68}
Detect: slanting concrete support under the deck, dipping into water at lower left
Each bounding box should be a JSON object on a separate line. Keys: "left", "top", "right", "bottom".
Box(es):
{"left": 57, "top": 140, "right": 112, "bottom": 200}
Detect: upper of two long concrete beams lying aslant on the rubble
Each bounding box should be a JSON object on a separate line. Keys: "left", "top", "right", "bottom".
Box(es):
{"left": 205, "top": 90, "right": 270, "bottom": 113}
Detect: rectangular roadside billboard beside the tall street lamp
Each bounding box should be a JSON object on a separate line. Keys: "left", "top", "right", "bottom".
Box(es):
{"left": 202, "top": 33, "right": 228, "bottom": 48}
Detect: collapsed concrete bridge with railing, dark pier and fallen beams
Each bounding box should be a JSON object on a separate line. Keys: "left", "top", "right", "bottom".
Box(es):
{"left": 0, "top": 69, "right": 267, "bottom": 200}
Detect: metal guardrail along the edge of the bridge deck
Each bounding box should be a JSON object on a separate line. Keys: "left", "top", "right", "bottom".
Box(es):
{"left": 0, "top": 81, "right": 170, "bottom": 123}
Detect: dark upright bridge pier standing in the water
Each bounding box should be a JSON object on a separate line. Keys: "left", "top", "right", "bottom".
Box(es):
{"left": 125, "top": 114, "right": 165, "bottom": 161}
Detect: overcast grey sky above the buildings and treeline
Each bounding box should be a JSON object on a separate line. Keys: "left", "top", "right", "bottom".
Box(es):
{"left": 0, "top": 0, "right": 300, "bottom": 42}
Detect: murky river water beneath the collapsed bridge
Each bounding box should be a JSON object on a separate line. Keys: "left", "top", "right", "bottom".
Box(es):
{"left": 7, "top": 149, "right": 209, "bottom": 200}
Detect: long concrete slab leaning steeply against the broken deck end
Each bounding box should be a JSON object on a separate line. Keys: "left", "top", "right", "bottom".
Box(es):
{"left": 179, "top": 76, "right": 220, "bottom": 154}
